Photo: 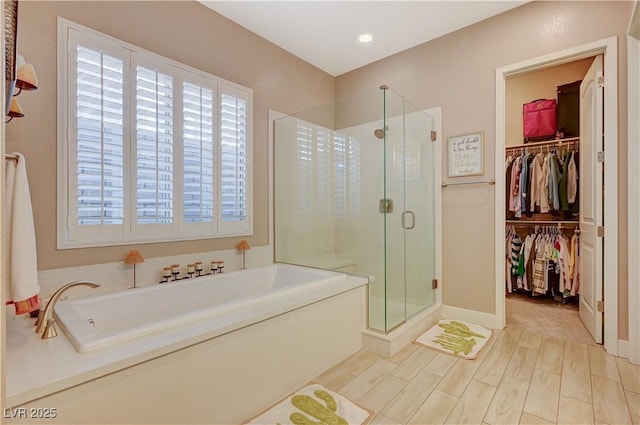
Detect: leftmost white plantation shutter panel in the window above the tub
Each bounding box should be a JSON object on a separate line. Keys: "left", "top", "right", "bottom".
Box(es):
{"left": 66, "top": 31, "right": 128, "bottom": 240}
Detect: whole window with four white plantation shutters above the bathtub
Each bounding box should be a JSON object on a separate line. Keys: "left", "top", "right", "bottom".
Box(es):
{"left": 58, "top": 18, "right": 253, "bottom": 248}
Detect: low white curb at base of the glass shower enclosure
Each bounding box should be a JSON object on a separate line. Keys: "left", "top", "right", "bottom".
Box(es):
{"left": 362, "top": 305, "right": 442, "bottom": 356}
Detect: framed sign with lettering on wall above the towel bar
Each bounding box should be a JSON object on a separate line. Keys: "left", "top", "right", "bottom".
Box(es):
{"left": 447, "top": 131, "right": 484, "bottom": 177}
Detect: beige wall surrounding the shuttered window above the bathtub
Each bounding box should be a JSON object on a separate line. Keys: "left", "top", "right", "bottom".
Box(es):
{"left": 6, "top": 1, "right": 335, "bottom": 270}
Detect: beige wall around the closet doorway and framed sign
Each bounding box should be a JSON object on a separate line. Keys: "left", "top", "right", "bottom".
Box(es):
{"left": 336, "top": 1, "right": 630, "bottom": 339}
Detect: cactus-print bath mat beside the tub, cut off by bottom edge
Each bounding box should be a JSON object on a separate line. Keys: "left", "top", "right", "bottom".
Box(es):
{"left": 246, "top": 384, "right": 373, "bottom": 425}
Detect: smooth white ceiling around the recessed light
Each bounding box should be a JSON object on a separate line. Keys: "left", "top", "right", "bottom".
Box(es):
{"left": 199, "top": 0, "right": 527, "bottom": 76}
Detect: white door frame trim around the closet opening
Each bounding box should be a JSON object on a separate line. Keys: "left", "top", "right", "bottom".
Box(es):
{"left": 495, "top": 37, "right": 618, "bottom": 355}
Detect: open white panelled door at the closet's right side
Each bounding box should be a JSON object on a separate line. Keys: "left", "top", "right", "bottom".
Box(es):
{"left": 579, "top": 55, "right": 604, "bottom": 344}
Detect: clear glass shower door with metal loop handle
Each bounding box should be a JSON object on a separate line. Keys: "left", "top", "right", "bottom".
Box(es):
{"left": 383, "top": 89, "right": 435, "bottom": 332}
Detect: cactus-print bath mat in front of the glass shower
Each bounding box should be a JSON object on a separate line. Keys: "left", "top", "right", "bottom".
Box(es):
{"left": 414, "top": 319, "right": 492, "bottom": 359}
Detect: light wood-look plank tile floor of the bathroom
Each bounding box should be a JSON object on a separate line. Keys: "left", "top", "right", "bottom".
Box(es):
{"left": 314, "top": 327, "right": 640, "bottom": 425}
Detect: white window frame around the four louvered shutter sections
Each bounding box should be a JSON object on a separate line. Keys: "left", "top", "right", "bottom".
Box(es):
{"left": 56, "top": 17, "right": 253, "bottom": 249}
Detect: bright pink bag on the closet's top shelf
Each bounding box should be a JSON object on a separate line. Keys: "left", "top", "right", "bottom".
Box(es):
{"left": 522, "top": 99, "right": 557, "bottom": 143}
